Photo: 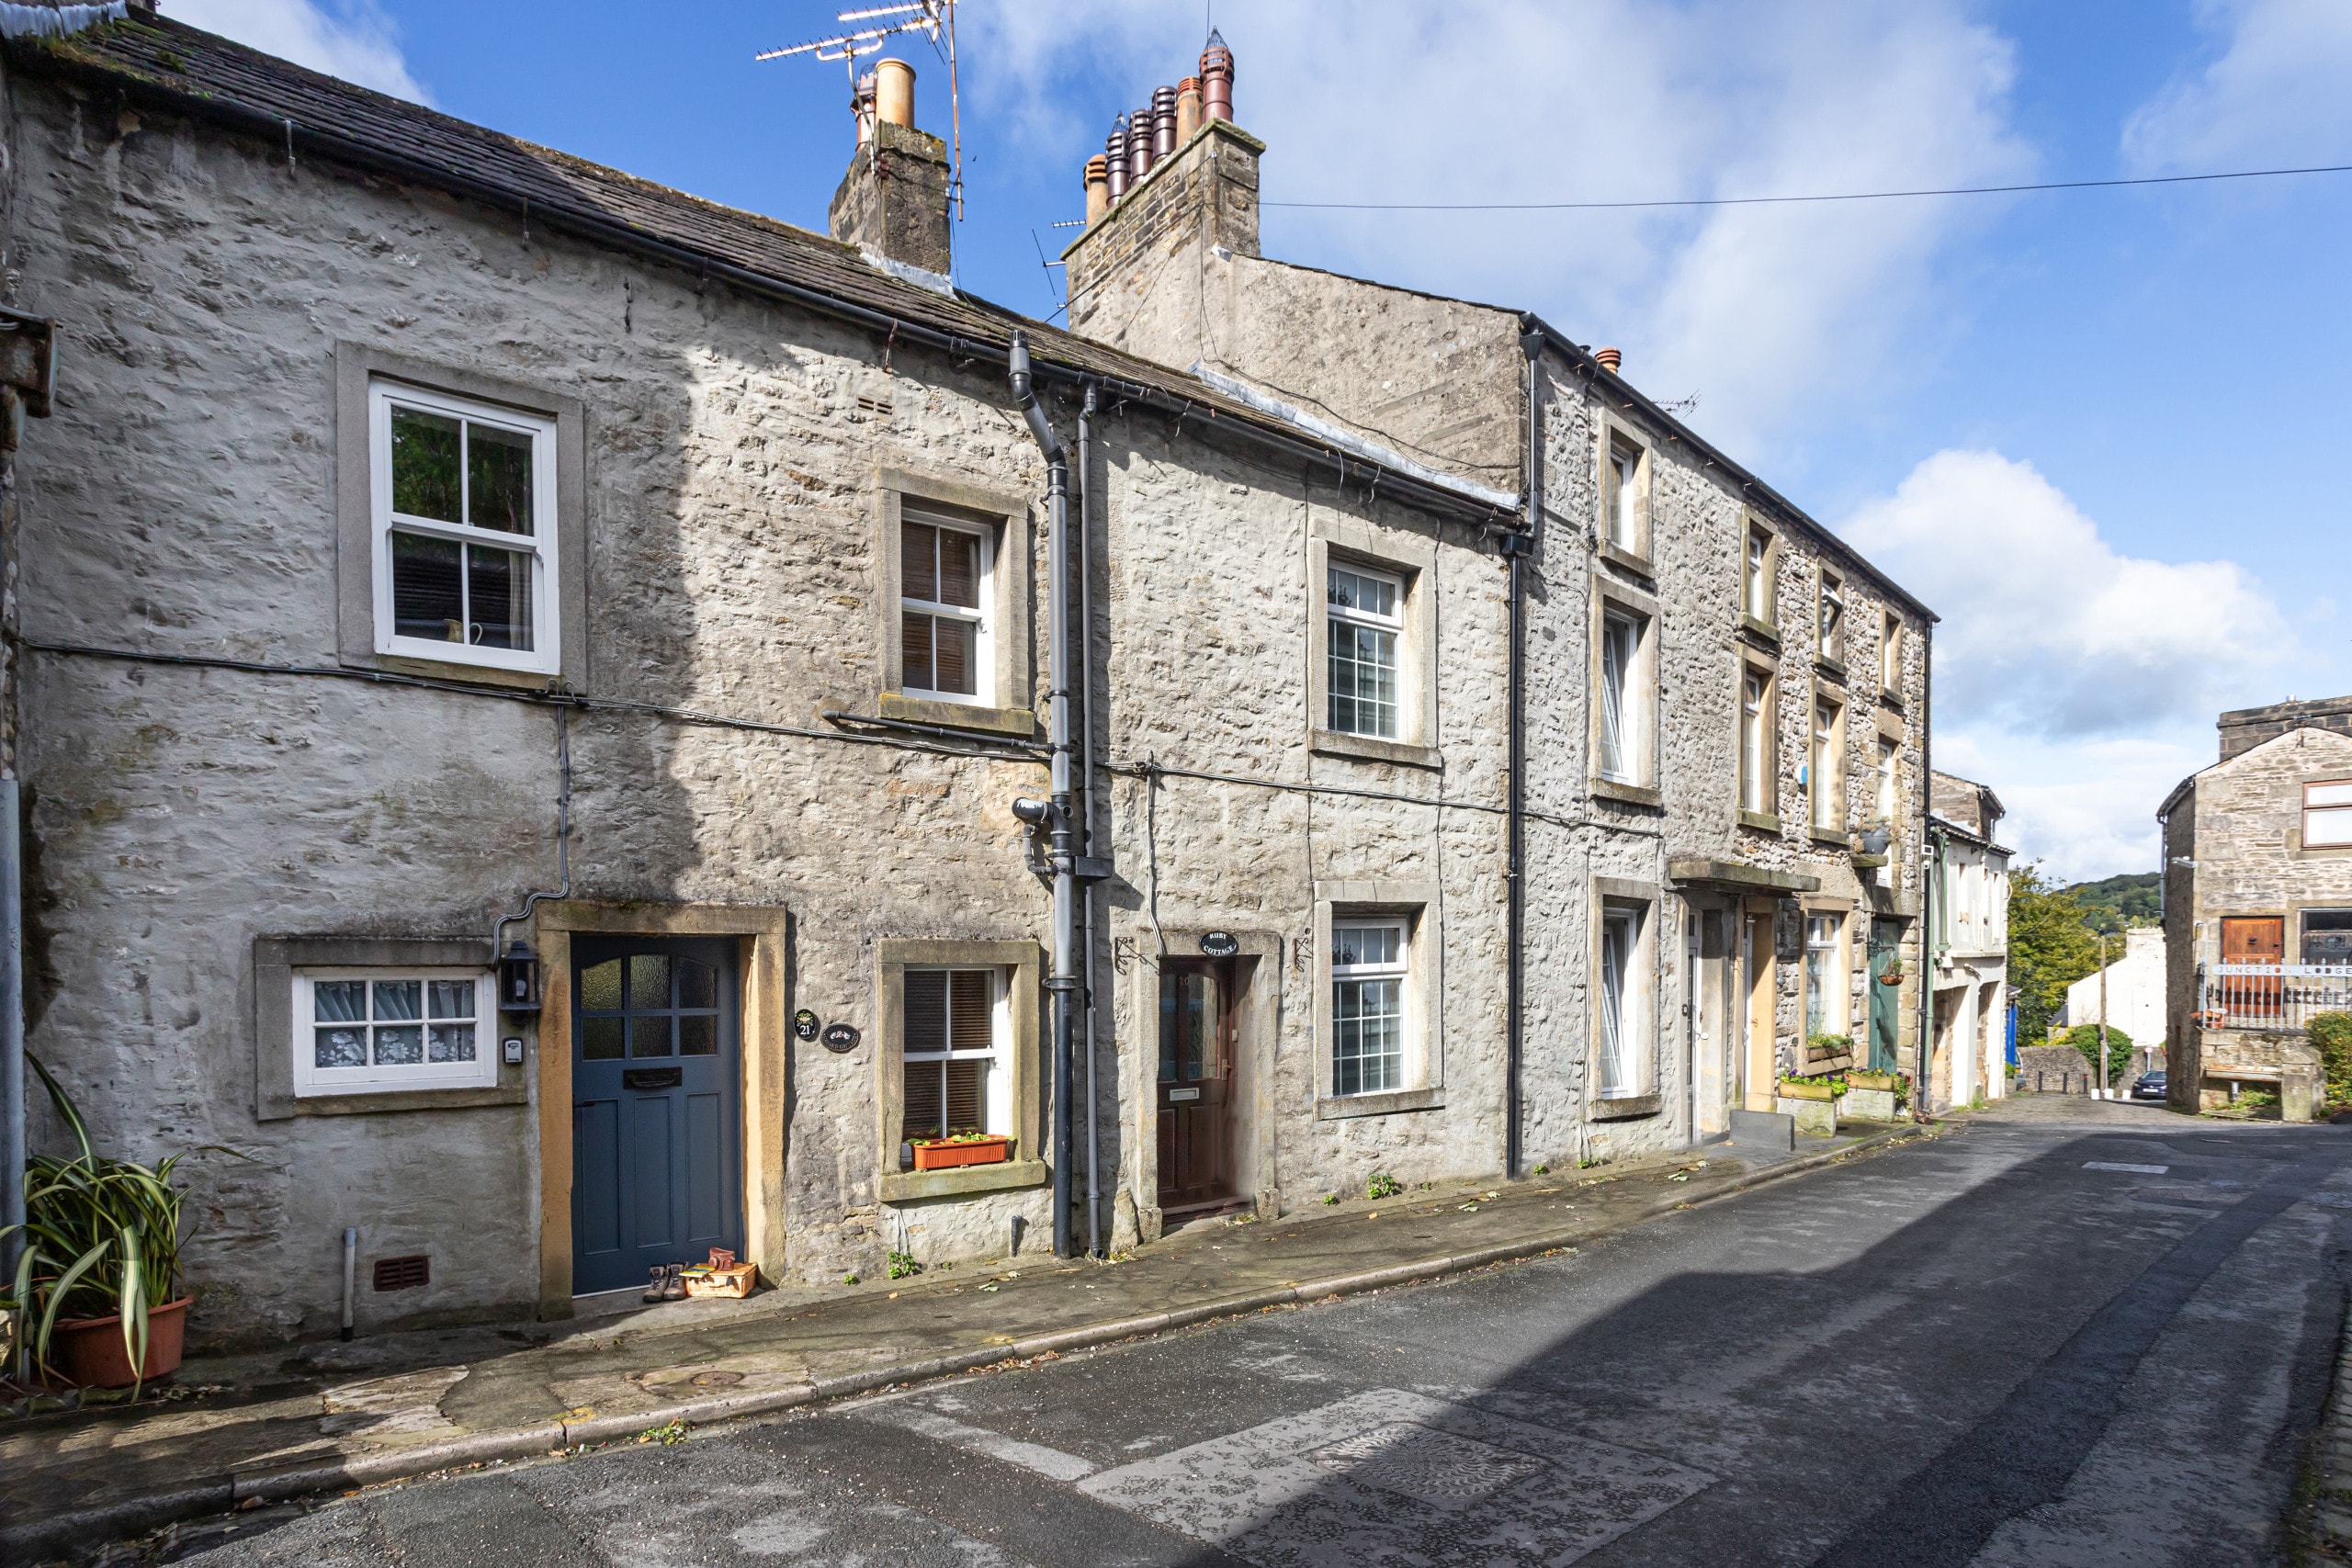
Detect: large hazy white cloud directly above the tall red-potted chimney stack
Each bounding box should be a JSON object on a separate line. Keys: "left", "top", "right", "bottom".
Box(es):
{"left": 965, "top": 0, "right": 2032, "bottom": 461}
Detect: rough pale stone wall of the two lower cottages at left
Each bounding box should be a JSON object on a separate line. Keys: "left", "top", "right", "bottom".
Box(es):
{"left": 9, "top": 85, "right": 1503, "bottom": 1340}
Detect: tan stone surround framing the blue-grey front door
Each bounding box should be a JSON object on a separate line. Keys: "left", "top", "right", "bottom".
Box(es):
{"left": 532, "top": 898, "right": 793, "bottom": 1321}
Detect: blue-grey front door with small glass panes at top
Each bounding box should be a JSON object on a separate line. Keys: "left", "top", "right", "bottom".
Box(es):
{"left": 571, "top": 936, "right": 743, "bottom": 1295}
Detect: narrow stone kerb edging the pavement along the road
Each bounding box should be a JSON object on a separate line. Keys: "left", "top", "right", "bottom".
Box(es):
{"left": 0, "top": 1126, "right": 1928, "bottom": 1561}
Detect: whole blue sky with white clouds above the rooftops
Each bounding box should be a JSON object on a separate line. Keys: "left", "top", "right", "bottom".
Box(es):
{"left": 164, "top": 0, "right": 2352, "bottom": 877}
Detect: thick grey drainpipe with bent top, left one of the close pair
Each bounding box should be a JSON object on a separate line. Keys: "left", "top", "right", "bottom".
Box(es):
{"left": 1009, "top": 332, "right": 1080, "bottom": 1258}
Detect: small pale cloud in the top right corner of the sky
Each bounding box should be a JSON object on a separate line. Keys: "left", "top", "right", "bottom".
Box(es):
{"left": 2124, "top": 0, "right": 2352, "bottom": 174}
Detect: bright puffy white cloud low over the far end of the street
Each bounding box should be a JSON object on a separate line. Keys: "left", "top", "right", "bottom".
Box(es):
{"left": 1839, "top": 451, "right": 2296, "bottom": 879}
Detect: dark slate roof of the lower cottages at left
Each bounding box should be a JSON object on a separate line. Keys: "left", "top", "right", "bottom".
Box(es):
{"left": 7, "top": 14, "right": 1508, "bottom": 522}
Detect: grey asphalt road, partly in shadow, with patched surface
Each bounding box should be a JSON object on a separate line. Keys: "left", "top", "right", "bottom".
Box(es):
{"left": 165, "top": 1102, "right": 2352, "bottom": 1568}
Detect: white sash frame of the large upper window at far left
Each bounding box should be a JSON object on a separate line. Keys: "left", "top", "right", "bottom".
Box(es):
{"left": 367, "top": 378, "right": 567, "bottom": 674}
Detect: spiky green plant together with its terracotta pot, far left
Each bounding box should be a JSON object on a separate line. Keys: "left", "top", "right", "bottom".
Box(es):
{"left": 0, "top": 1055, "right": 247, "bottom": 1399}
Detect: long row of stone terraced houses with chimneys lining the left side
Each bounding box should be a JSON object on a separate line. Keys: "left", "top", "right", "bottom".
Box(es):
{"left": 0, "top": 7, "right": 1931, "bottom": 1345}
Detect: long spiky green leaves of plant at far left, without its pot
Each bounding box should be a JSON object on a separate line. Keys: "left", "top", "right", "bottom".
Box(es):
{"left": 0, "top": 1055, "right": 249, "bottom": 1399}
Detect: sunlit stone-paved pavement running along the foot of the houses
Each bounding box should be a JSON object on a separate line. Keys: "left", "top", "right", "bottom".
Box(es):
{"left": 0, "top": 1126, "right": 1933, "bottom": 1561}
